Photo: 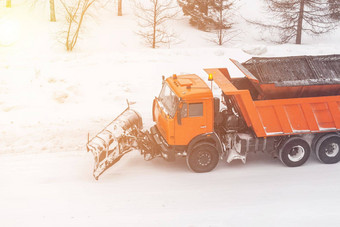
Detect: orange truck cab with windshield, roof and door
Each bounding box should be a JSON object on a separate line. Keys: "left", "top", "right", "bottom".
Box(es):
{"left": 153, "top": 74, "right": 214, "bottom": 146}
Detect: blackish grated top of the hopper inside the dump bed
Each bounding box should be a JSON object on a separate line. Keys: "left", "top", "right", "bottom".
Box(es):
{"left": 242, "top": 55, "right": 340, "bottom": 87}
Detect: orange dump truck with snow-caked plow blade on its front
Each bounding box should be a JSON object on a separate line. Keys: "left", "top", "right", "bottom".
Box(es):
{"left": 87, "top": 55, "right": 340, "bottom": 179}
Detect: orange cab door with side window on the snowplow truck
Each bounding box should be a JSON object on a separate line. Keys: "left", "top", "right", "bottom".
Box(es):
{"left": 175, "top": 100, "right": 210, "bottom": 145}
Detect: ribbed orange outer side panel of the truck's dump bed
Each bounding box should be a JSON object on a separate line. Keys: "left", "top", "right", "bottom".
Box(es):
{"left": 252, "top": 95, "right": 340, "bottom": 136}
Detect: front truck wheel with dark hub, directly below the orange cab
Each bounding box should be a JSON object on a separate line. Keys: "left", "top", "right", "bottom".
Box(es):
{"left": 186, "top": 143, "right": 219, "bottom": 173}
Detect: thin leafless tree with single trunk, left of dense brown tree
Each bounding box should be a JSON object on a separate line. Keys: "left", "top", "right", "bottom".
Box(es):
{"left": 135, "top": 0, "right": 178, "bottom": 48}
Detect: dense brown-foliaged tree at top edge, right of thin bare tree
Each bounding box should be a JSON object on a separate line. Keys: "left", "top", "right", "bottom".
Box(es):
{"left": 177, "top": 0, "right": 213, "bottom": 31}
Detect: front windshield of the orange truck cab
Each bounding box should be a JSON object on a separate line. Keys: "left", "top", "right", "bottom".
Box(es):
{"left": 158, "top": 83, "right": 179, "bottom": 118}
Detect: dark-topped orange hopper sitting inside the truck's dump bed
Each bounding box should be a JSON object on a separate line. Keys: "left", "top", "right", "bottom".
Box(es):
{"left": 236, "top": 55, "right": 340, "bottom": 99}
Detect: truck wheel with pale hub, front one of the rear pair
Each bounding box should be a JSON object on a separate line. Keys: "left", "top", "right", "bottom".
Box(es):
{"left": 279, "top": 137, "right": 310, "bottom": 167}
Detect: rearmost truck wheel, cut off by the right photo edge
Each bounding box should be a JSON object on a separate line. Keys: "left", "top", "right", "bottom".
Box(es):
{"left": 315, "top": 134, "right": 340, "bottom": 164}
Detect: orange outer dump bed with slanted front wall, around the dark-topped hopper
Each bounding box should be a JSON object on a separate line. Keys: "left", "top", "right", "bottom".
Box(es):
{"left": 205, "top": 62, "right": 340, "bottom": 137}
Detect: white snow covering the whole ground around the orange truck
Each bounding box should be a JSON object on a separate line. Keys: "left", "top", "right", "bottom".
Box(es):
{"left": 0, "top": 0, "right": 340, "bottom": 227}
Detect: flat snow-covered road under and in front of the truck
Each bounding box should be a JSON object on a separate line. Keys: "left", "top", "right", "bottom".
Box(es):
{"left": 0, "top": 152, "right": 340, "bottom": 227}
